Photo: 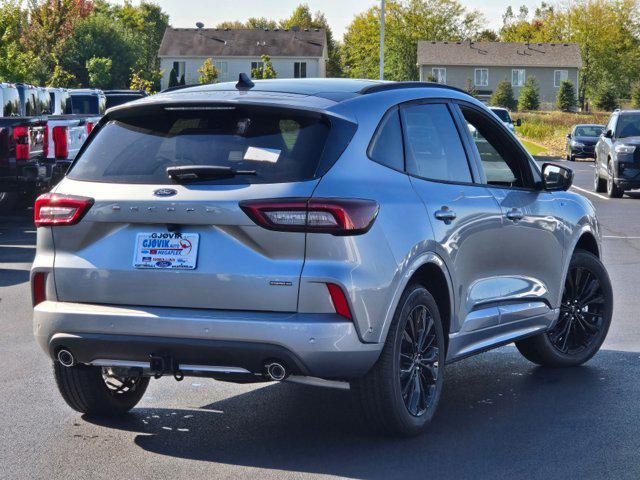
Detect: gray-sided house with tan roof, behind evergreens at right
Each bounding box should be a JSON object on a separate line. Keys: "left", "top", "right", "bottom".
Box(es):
{"left": 418, "top": 41, "right": 582, "bottom": 106}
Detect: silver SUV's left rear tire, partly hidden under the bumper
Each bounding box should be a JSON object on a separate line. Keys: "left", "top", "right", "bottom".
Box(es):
{"left": 53, "top": 362, "right": 149, "bottom": 417}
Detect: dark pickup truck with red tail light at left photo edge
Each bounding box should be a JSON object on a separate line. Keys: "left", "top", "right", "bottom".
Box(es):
{"left": 0, "top": 83, "right": 50, "bottom": 214}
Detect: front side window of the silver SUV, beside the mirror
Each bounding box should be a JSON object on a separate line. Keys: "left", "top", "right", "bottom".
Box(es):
{"left": 461, "top": 107, "right": 531, "bottom": 187}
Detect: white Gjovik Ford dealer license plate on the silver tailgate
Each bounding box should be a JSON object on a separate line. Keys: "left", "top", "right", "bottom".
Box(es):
{"left": 133, "top": 232, "right": 200, "bottom": 270}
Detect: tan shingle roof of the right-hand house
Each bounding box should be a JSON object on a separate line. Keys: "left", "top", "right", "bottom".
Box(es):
{"left": 418, "top": 41, "right": 582, "bottom": 68}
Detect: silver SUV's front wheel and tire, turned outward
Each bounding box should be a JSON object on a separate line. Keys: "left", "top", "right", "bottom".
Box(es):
{"left": 516, "top": 250, "right": 613, "bottom": 367}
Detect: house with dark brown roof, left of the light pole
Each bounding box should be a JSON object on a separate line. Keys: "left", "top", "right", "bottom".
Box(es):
{"left": 158, "top": 27, "right": 328, "bottom": 89}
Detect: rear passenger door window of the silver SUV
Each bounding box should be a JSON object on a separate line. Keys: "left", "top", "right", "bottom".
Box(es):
{"left": 400, "top": 104, "right": 472, "bottom": 183}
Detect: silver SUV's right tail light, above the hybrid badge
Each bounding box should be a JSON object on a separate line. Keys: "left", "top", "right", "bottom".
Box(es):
{"left": 240, "top": 198, "right": 378, "bottom": 235}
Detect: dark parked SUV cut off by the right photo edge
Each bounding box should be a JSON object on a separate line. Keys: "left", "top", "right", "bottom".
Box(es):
{"left": 593, "top": 110, "right": 640, "bottom": 198}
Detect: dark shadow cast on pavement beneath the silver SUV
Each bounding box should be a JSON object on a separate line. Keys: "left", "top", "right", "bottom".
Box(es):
{"left": 86, "top": 347, "right": 640, "bottom": 479}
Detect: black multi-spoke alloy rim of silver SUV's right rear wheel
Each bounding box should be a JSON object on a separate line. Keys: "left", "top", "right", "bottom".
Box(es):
{"left": 399, "top": 305, "right": 440, "bottom": 417}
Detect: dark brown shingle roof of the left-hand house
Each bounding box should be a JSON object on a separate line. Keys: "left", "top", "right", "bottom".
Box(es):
{"left": 158, "top": 27, "right": 327, "bottom": 57}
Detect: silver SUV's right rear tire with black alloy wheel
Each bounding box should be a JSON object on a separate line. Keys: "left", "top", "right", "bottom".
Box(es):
{"left": 352, "top": 284, "right": 446, "bottom": 437}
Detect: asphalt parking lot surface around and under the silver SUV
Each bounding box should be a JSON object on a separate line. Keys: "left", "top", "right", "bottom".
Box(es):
{"left": 0, "top": 159, "right": 640, "bottom": 479}
